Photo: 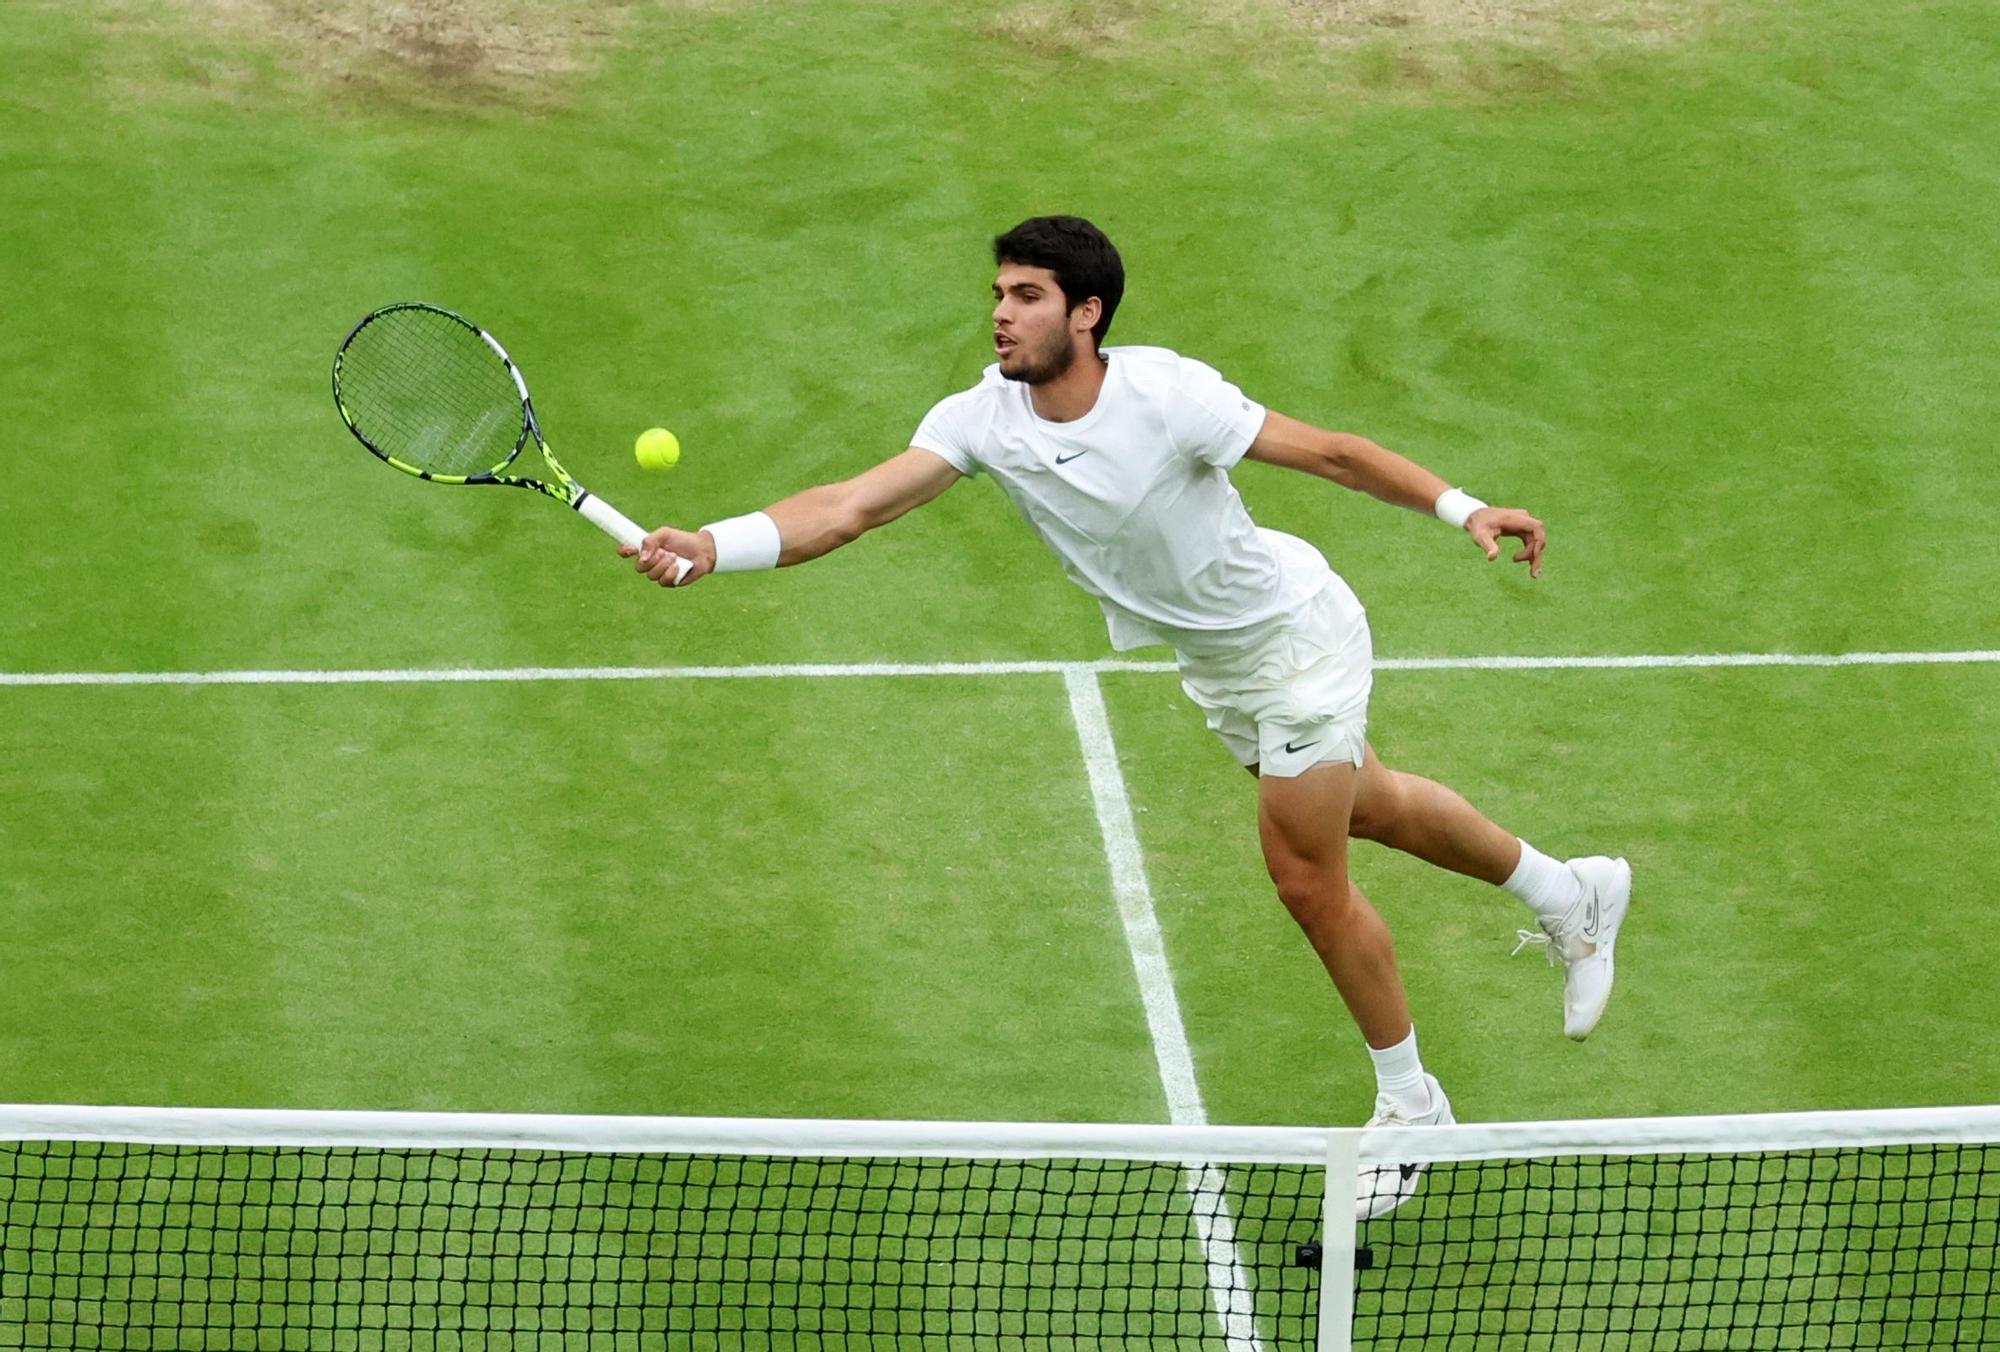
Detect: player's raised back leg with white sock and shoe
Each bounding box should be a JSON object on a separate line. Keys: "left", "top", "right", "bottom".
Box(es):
{"left": 1348, "top": 746, "right": 1632, "bottom": 1038}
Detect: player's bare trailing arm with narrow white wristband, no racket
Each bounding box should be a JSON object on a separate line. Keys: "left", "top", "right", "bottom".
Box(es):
{"left": 1244, "top": 414, "right": 1548, "bottom": 578}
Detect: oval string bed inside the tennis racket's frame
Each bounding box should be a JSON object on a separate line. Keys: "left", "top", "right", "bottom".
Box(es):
{"left": 340, "top": 308, "right": 526, "bottom": 476}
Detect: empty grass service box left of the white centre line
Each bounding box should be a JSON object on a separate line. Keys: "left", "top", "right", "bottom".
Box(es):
{"left": 0, "top": 678, "right": 1162, "bottom": 1120}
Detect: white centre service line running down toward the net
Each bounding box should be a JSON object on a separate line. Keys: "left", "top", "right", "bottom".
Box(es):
{"left": 1062, "top": 668, "right": 1264, "bottom": 1352}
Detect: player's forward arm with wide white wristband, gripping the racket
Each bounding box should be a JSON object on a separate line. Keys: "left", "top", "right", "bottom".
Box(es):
{"left": 618, "top": 446, "right": 962, "bottom": 586}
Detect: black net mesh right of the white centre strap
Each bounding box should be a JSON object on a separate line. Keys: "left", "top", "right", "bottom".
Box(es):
{"left": 1354, "top": 1144, "right": 2000, "bottom": 1352}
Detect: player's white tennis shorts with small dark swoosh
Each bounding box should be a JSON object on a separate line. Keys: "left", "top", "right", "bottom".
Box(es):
{"left": 1176, "top": 574, "right": 1374, "bottom": 778}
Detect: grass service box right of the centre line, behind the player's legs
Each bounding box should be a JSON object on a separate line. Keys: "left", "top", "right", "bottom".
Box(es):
{"left": 1106, "top": 668, "right": 2000, "bottom": 1122}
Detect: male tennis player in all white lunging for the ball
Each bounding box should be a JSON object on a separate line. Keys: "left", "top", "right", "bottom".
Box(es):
{"left": 620, "top": 216, "right": 1632, "bottom": 1218}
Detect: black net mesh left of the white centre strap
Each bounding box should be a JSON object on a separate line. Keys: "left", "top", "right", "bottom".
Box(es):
{"left": 0, "top": 1142, "right": 1318, "bottom": 1350}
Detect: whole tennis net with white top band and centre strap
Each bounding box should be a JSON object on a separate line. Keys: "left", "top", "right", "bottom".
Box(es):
{"left": 0, "top": 1108, "right": 2000, "bottom": 1352}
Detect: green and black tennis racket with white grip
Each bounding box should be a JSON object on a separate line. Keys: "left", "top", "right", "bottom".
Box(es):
{"left": 334, "top": 302, "right": 694, "bottom": 582}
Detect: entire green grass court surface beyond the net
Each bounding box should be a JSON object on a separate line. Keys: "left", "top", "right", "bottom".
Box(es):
{"left": 0, "top": 0, "right": 2000, "bottom": 1344}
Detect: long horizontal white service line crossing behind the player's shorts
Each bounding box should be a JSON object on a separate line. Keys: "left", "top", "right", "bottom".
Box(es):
{"left": 0, "top": 648, "right": 2000, "bottom": 686}
